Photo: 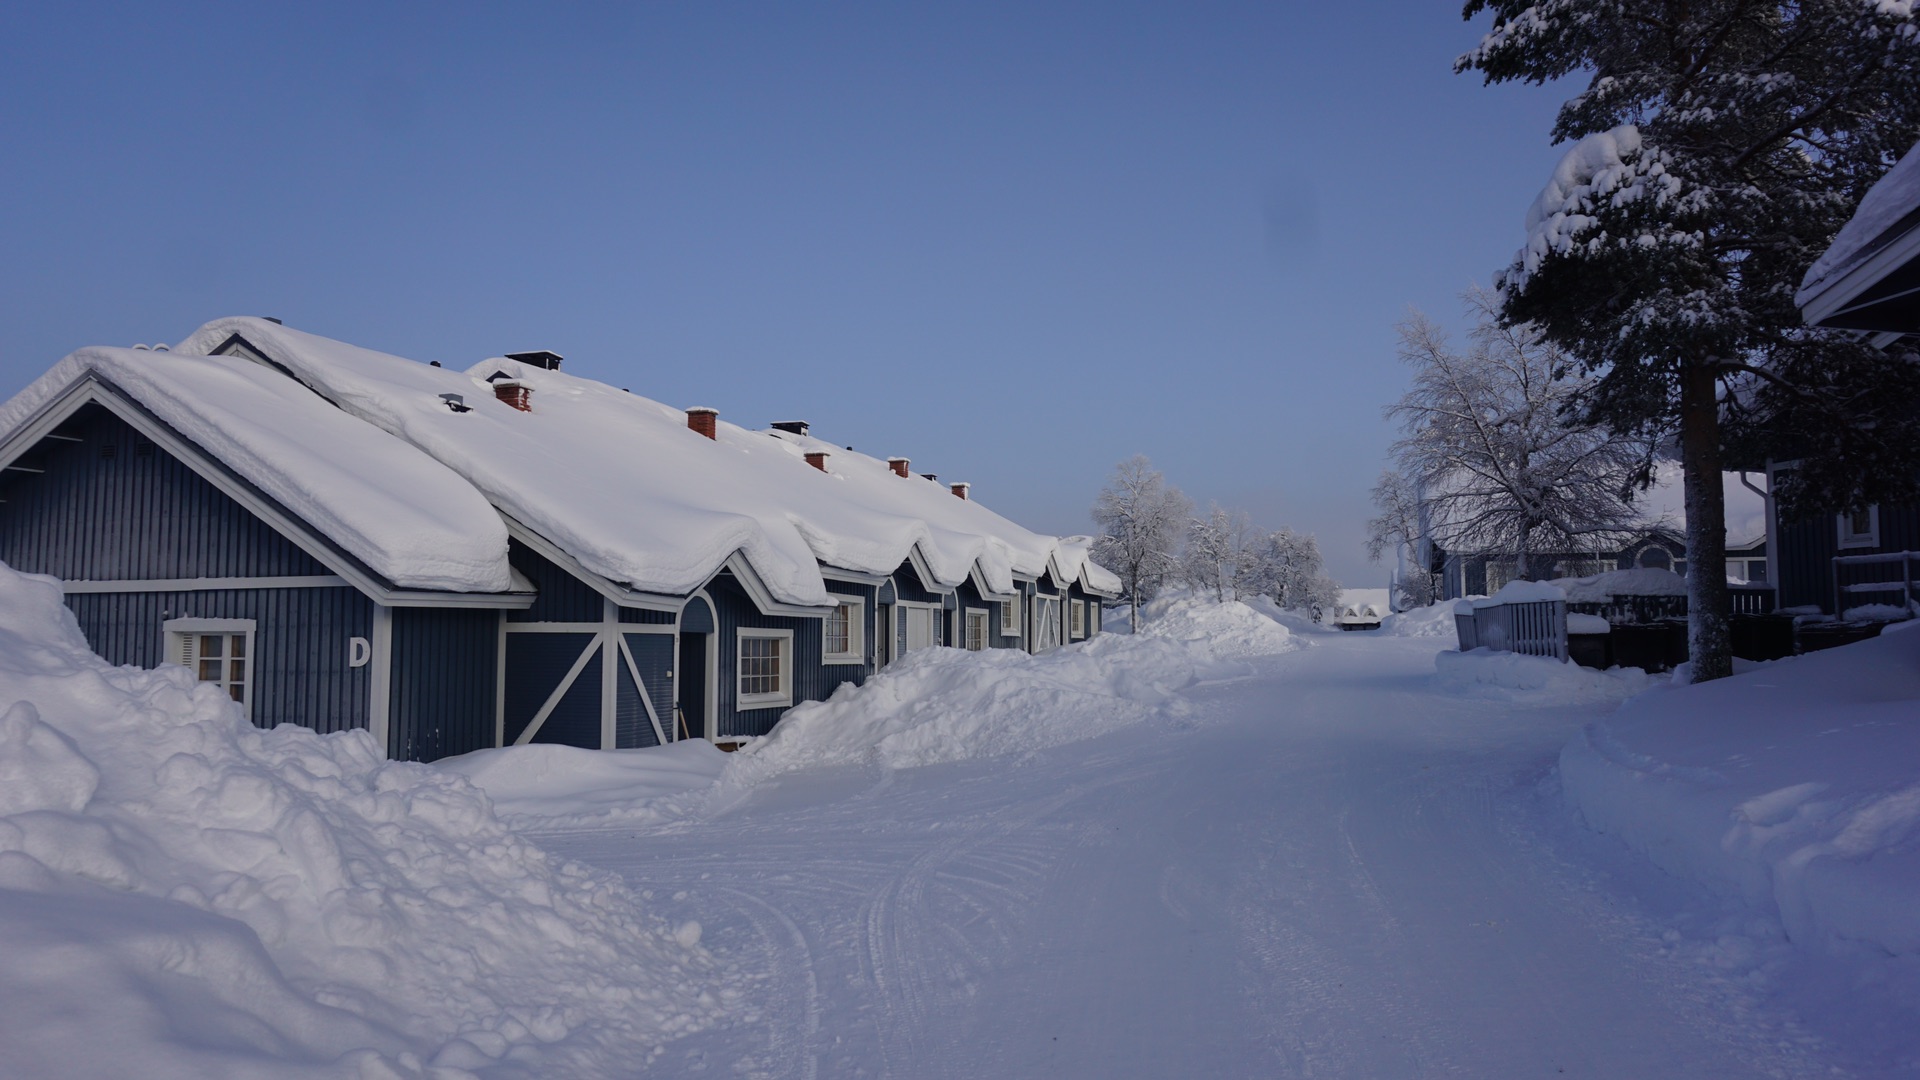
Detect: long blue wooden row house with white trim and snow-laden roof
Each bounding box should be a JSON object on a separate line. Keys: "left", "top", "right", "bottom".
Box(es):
{"left": 0, "top": 319, "right": 1117, "bottom": 759}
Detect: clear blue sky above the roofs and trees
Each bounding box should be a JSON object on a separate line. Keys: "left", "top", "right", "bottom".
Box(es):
{"left": 0, "top": 0, "right": 1563, "bottom": 586}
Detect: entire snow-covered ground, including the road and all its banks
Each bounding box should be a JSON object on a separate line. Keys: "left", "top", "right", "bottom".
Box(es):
{"left": 0, "top": 577, "right": 1920, "bottom": 1078}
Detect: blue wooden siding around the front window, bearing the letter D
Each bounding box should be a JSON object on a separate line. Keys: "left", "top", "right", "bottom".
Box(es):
{"left": 67, "top": 586, "right": 370, "bottom": 732}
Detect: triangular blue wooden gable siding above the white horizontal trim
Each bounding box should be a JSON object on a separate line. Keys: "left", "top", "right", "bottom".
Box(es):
{"left": 0, "top": 405, "right": 332, "bottom": 580}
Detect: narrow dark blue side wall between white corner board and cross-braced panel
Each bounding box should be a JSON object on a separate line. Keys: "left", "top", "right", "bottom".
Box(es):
{"left": 388, "top": 607, "right": 501, "bottom": 761}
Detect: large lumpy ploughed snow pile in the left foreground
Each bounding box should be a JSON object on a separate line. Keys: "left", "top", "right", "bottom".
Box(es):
{"left": 0, "top": 565, "right": 718, "bottom": 1078}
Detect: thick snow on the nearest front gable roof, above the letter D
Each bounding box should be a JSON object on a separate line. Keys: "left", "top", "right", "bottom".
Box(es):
{"left": 0, "top": 342, "right": 511, "bottom": 592}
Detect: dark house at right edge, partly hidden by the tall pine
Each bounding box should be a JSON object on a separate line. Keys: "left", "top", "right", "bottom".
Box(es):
{"left": 1766, "top": 144, "right": 1920, "bottom": 615}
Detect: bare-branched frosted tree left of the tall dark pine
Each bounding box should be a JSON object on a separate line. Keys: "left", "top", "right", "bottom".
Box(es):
{"left": 1377, "top": 288, "right": 1653, "bottom": 578}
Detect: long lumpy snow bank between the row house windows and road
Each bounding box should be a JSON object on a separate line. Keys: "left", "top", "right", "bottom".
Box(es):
{"left": 722, "top": 600, "right": 1296, "bottom": 784}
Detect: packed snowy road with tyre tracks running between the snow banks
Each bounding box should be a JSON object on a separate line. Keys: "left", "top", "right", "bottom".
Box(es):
{"left": 540, "top": 636, "right": 1828, "bottom": 1078}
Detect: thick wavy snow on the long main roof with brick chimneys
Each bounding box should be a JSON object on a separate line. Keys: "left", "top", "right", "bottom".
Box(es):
{"left": 179, "top": 319, "right": 1114, "bottom": 605}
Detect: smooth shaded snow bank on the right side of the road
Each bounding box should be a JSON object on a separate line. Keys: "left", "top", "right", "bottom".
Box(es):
{"left": 1561, "top": 634, "right": 1920, "bottom": 959}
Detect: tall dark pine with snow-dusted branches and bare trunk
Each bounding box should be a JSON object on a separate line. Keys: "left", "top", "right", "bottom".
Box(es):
{"left": 1455, "top": 0, "right": 1920, "bottom": 680}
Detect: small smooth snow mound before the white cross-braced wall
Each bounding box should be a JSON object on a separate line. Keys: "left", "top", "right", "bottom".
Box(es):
{"left": 434, "top": 740, "right": 728, "bottom": 828}
